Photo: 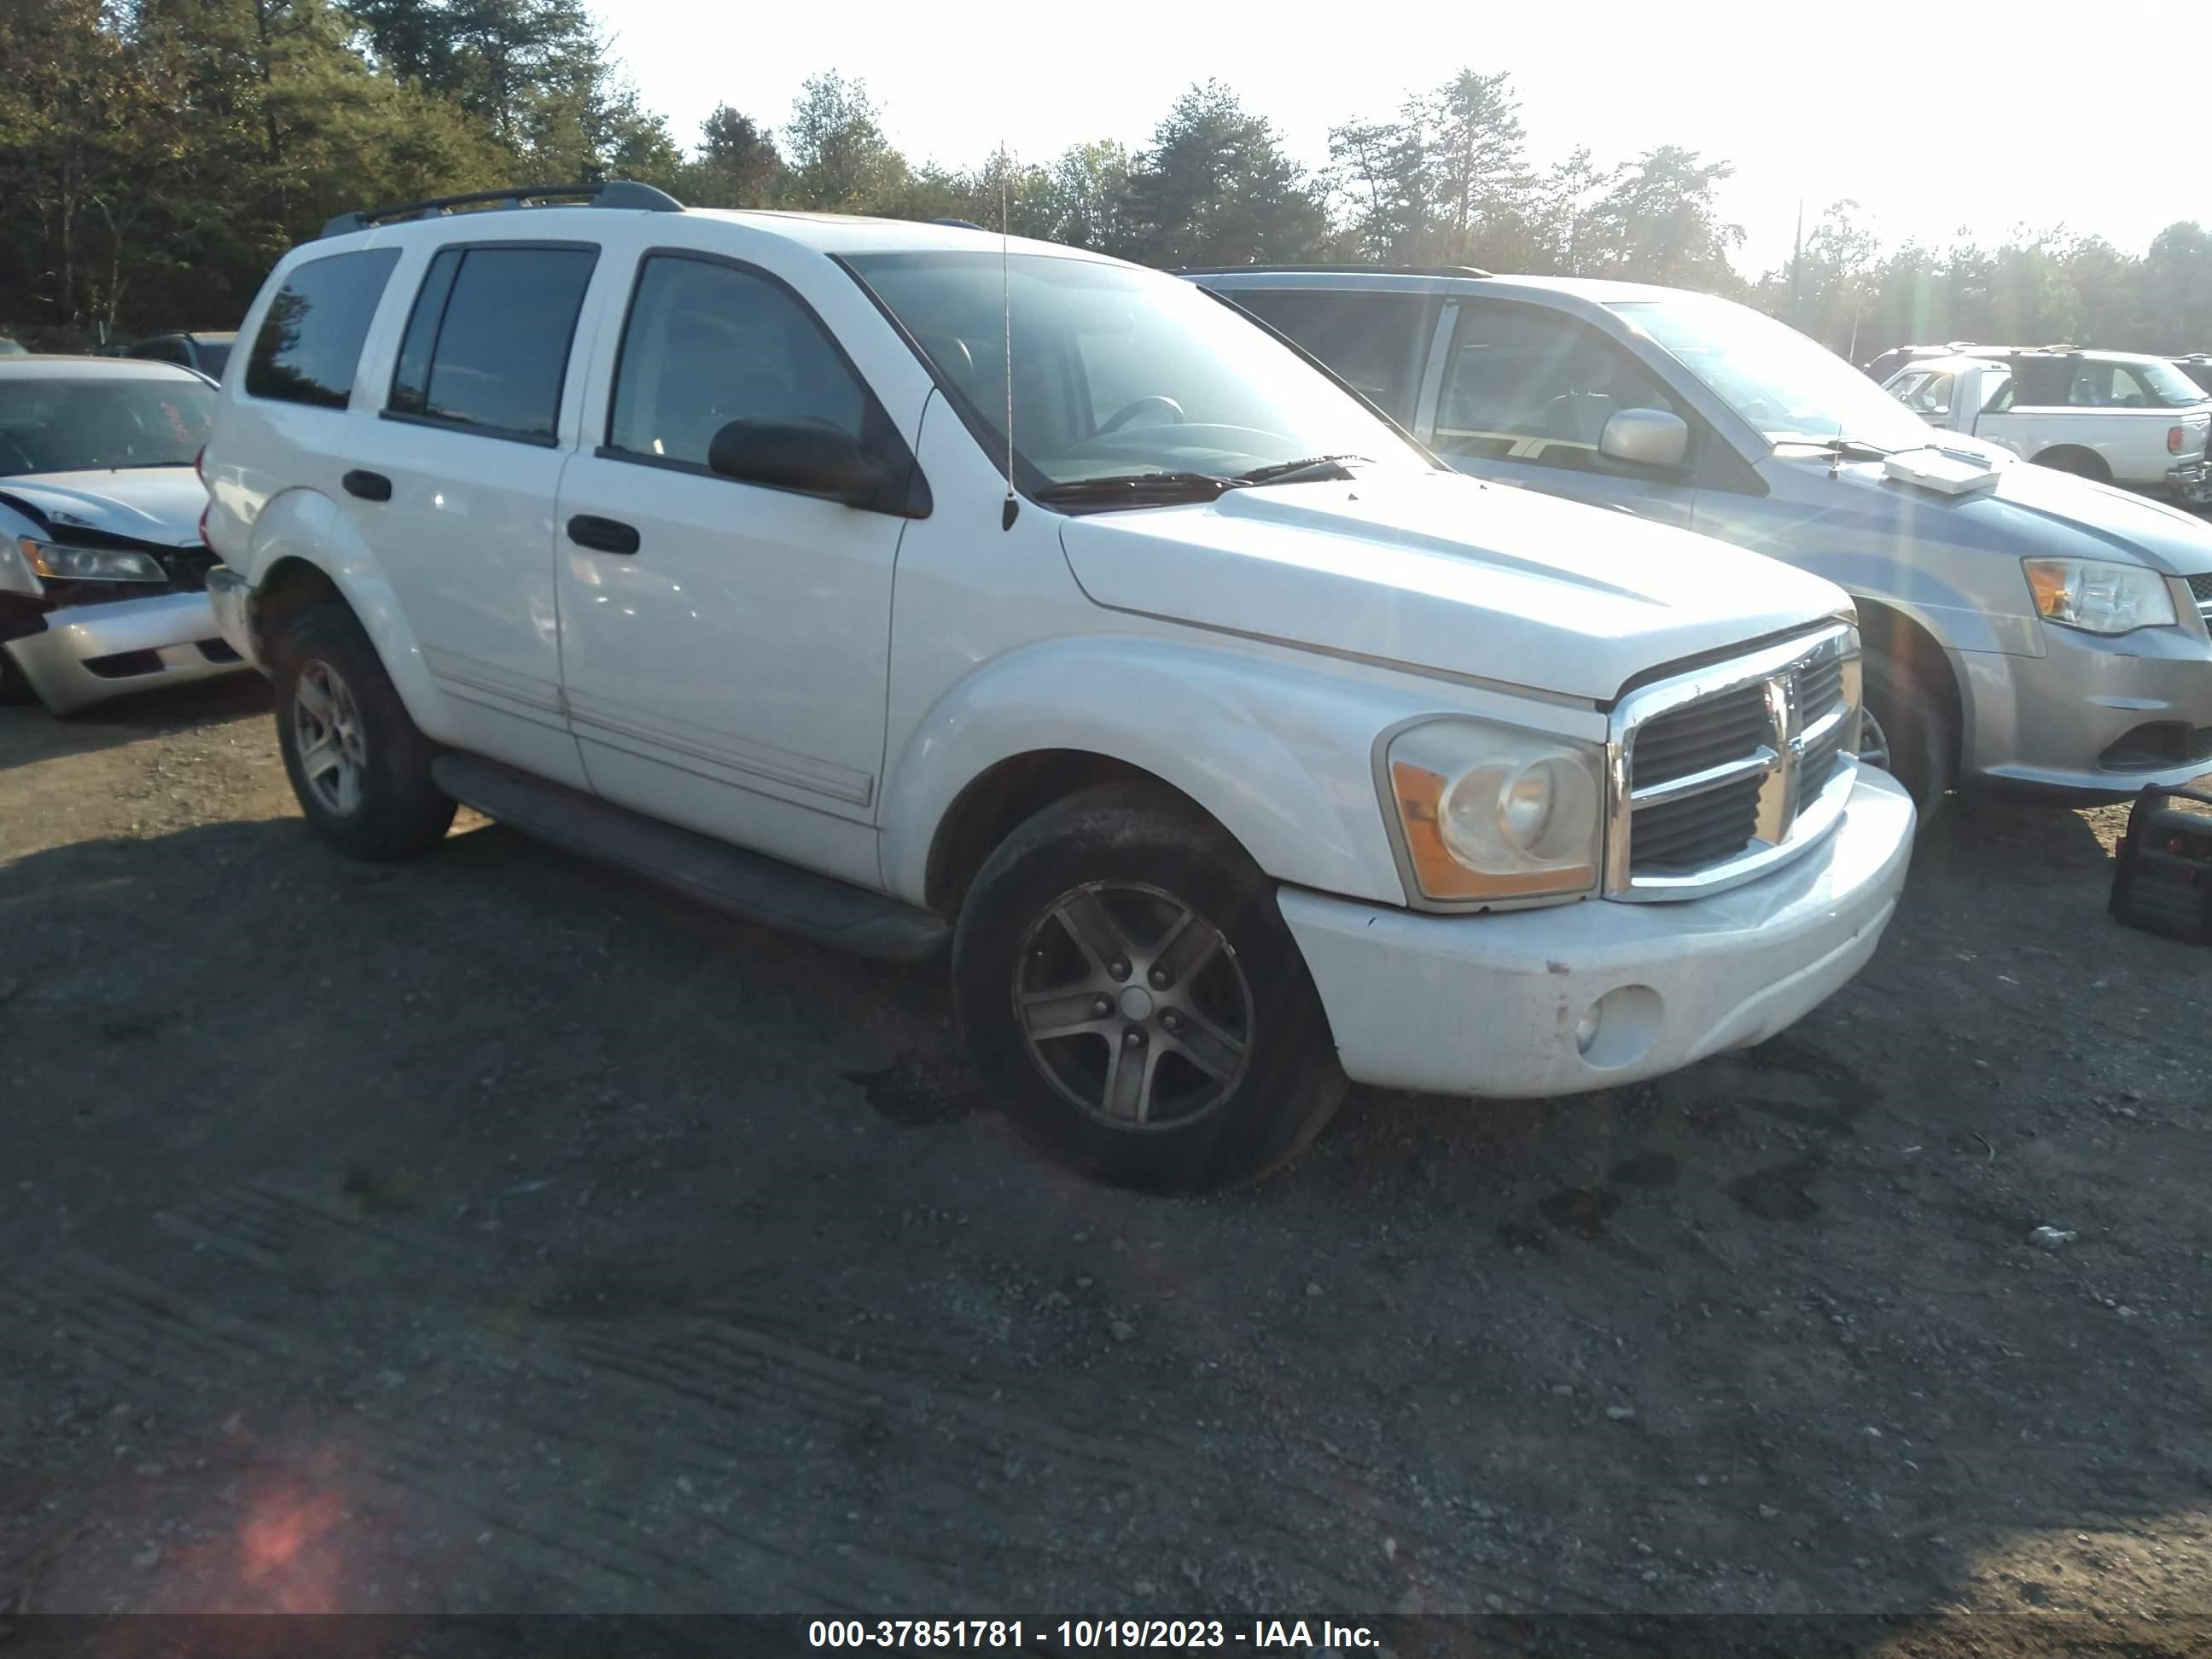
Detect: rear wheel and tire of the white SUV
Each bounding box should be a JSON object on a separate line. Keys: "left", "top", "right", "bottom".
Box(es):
{"left": 270, "top": 599, "right": 453, "bottom": 863}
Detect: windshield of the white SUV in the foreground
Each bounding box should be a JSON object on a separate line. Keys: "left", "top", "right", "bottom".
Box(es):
{"left": 845, "top": 252, "right": 1427, "bottom": 493}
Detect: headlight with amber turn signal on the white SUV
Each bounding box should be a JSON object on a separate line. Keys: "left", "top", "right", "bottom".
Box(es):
{"left": 1385, "top": 717, "right": 1606, "bottom": 903}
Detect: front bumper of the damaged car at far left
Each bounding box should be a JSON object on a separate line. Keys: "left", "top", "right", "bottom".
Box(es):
{"left": 0, "top": 593, "right": 246, "bottom": 714}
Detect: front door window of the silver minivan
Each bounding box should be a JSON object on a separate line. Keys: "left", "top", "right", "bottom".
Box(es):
{"left": 1435, "top": 303, "right": 1684, "bottom": 471}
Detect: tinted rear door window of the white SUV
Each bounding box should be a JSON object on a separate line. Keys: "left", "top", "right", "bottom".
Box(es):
{"left": 389, "top": 243, "right": 599, "bottom": 445}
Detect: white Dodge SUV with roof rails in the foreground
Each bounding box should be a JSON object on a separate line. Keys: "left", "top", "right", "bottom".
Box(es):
{"left": 206, "top": 186, "right": 1913, "bottom": 1185}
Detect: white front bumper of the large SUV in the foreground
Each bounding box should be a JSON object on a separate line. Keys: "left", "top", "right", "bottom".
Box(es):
{"left": 1281, "top": 770, "right": 1913, "bottom": 1097}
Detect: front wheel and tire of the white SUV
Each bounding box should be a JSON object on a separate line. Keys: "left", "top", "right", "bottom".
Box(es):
{"left": 953, "top": 785, "right": 1348, "bottom": 1192}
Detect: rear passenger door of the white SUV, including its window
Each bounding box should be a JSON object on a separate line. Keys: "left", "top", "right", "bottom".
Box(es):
{"left": 339, "top": 229, "right": 599, "bottom": 788}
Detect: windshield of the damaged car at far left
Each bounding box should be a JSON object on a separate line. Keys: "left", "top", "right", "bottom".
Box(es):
{"left": 0, "top": 376, "right": 214, "bottom": 478}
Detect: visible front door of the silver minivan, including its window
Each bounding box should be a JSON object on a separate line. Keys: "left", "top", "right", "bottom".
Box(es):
{"left": 1431, "top": 299, "right": 1699, "bottom": 524}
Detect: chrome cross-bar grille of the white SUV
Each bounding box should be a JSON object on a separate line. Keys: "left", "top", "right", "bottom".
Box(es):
{"left": 1606, "top": 626, "right": 1858, "bottom": 898}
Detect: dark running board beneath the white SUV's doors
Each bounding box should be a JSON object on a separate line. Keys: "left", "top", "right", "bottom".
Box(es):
{"left": 429, "top": 754, "right": 953, "bottom": 963}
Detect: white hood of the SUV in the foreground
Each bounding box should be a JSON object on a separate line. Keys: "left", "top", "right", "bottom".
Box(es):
{"left": 1060, "top": 474, "right": 1849, "bottom": 703}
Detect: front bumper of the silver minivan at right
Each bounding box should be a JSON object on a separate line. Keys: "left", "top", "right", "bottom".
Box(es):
{"left": 1951, "top": 606, "right": 2212, "bottom": 799}
